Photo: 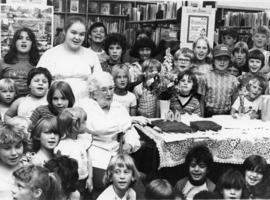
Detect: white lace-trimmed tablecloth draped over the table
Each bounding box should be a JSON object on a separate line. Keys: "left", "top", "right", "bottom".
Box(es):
{"left": 136, "top": 115, "right": 270, "bottom": 169}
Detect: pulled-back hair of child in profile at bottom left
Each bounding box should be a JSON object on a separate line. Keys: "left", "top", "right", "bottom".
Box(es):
{"left": 13, "top": 165, "right": 60, "bottom": 200}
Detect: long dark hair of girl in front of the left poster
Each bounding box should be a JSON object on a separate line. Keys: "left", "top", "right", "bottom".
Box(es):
{"left": 4, "top": 27, "right": 40, "bottom": 66}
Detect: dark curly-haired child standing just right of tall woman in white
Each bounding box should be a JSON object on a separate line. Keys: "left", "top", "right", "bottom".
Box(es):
{"left": 102, "top": 33, "right": 127, "bottom": 72}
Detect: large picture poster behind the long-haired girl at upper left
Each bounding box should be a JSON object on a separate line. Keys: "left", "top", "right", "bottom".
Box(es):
{"left": 0, "top": 4, "right": 53, "bottom": 57}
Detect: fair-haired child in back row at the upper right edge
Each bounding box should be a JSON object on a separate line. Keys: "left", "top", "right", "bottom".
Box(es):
{"left": 249, "top": 26, "right": 270, "bottom": 79}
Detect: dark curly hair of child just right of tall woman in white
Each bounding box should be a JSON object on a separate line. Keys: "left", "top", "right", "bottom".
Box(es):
{"left": 104, "top": 33, "right": 127, "bottom": 55}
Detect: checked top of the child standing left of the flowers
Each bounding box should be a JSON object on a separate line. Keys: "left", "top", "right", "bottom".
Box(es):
{"left": 133, "top": 83, "right": 158, "bottom": 118}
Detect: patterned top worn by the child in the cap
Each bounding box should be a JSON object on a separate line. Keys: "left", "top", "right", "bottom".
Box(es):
{"left": 199, "top": 70, "right": 239, "bottom": 114}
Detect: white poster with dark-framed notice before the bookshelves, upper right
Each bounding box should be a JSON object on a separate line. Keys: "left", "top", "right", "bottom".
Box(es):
{"left": 180, "top": 7, "right": 216, "bottom": 48}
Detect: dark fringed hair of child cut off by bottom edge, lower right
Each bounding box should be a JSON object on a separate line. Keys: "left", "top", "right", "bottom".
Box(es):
{"left": 217, "top": 168, "right": 245, "bottom": 196}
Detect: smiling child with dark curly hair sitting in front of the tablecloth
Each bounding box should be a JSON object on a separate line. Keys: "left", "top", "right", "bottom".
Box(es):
{"left": 175, "top": 145, "right": 215, "bottom": 199}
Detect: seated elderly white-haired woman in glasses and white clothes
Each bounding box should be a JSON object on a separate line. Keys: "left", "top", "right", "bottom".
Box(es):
{"left": 78, "top": 72, "right": 140, "bottom": 197}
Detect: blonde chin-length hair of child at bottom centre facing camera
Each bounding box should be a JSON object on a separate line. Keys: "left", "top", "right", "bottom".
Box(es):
{"left": 103, "top": 154, "right": 139, "bottom": 187}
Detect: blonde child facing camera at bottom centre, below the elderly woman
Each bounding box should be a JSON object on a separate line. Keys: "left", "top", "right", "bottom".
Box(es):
{"left": 97, "top": 154, "right": 138, "bottom": 200}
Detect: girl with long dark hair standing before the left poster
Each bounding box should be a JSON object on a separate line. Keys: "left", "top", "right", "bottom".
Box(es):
{"left": 0, "top": 27, "right": 39, "bottom": 96}
